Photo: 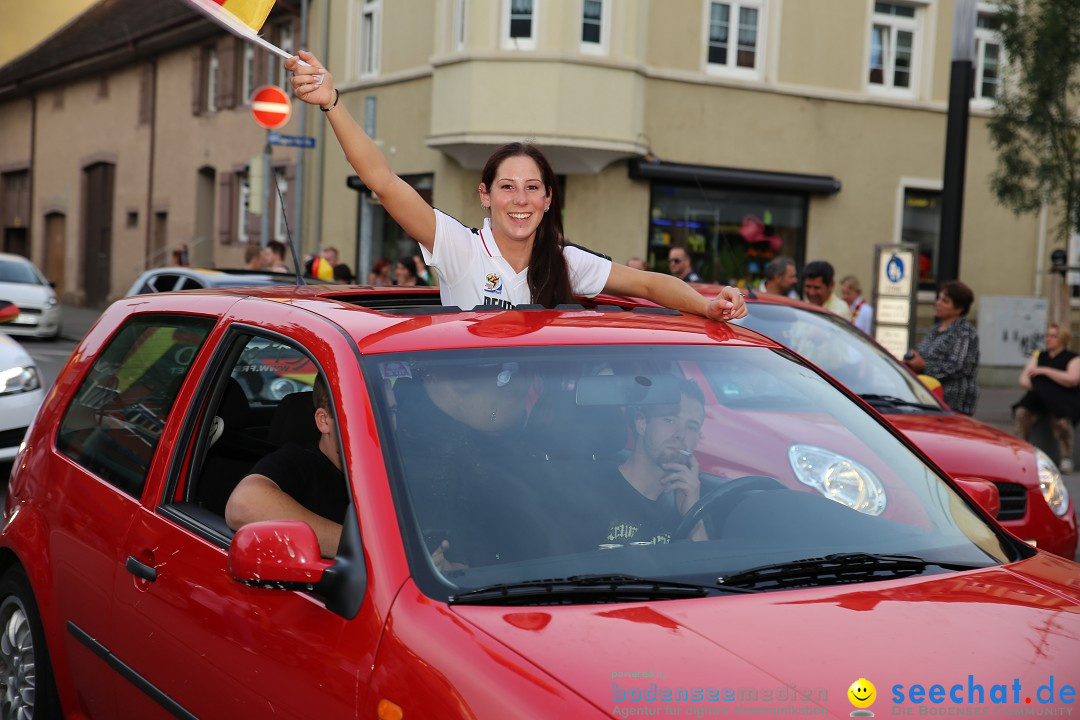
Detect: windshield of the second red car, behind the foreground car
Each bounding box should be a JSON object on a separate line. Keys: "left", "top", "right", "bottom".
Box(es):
{"left": 737, "top": 302, "right": 941, "bottom": 408}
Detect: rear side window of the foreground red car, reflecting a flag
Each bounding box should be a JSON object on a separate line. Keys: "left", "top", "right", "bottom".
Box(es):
{"left": 57, "top": 316, "right": 214, "bottom": 495}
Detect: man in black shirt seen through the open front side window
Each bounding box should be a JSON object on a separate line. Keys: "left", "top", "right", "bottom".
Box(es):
{"left": 225, "top": 376, "right": 349, "bottom": 557}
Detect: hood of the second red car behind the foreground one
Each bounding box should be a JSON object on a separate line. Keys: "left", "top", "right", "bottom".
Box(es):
{"left": 886, "top": 412, "right": 1039, "bottom": 487}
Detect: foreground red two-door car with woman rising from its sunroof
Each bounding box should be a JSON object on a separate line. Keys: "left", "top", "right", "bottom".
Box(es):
{"left": 0, "top": 287, "right": 1080, "bottom": 719}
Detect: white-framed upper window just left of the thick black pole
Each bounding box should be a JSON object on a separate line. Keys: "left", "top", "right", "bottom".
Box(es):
{"left": 868, "top": 2, "right": 922, "bottom": 95}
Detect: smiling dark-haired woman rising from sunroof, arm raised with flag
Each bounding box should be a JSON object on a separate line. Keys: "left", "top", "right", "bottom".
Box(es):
{"left": 285, "top": 51, "right": 746, "bottom": 321}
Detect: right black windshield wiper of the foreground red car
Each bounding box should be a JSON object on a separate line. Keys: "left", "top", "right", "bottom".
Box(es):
{"left": 716, "top": 553, "right": 986, "bottom": 589}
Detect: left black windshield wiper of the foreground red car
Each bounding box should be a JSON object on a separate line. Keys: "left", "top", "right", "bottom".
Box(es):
{"left": 447, "top": 575, "right": 756, "bottom": 606}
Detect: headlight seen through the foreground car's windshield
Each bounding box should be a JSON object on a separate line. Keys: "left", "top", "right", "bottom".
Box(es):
{"left": 787, "top": 445, "right": 886, "bottom": 515}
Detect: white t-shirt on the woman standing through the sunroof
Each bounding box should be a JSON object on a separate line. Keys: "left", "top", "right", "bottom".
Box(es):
{"left": 420, "top": 209, "right": 611, "bottom": 310}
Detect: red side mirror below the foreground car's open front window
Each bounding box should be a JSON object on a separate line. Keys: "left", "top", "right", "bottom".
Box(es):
{"left": 229, "top": 520, "right": 334, "bottom": 592}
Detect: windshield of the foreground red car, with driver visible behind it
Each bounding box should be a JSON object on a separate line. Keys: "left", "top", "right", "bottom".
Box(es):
{"left": 365, "top": 345, "right": 1014, "bottom": 599}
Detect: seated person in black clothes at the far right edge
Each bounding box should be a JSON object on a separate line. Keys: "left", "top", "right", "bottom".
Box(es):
{"left": 1013, "top": 324, "right": 1080, "bottom": 473}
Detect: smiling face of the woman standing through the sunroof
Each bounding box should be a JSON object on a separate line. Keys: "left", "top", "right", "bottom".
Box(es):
{"left": 480, "top": 155, "right": 551, "bottom": 248}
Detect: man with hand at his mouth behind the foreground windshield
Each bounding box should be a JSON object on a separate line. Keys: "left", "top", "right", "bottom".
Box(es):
{"left": 591, "top": 380, "right": 707, "bottom": 545}
